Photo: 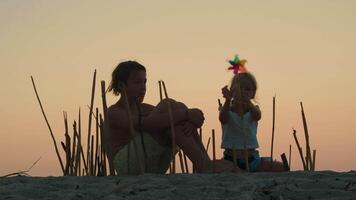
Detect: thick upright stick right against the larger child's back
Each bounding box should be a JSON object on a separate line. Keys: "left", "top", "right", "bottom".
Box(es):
{"left": 101, "top": 81, "right": 115, "bottom": 176}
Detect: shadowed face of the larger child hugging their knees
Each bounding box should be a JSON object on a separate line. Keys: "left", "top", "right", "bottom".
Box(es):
{"left": 126, "top": 70, "right": 147, "bottom": 103}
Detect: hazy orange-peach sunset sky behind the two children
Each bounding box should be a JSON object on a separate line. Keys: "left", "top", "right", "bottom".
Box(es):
{"left": 0, "top": 0, "right": 356, "bottom": 176}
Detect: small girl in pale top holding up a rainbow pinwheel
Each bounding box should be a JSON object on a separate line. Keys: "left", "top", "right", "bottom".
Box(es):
{"left": 219, "top": 58, "right": 284, "bottom": 172}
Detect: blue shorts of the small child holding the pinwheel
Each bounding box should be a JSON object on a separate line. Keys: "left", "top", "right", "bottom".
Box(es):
{"left": 224, "top": 151, "right": 271, "bottom": 172}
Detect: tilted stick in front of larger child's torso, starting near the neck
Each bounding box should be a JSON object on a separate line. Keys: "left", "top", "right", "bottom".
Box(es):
{"left": 121, "top": 84, "right": 145, "bottom": 174}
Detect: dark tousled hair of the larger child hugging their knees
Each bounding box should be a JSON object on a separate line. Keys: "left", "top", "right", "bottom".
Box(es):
{"left": 108, "top": 60, "right": 146, "bottom": 95}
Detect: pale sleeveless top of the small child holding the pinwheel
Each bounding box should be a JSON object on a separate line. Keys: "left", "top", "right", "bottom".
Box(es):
{"left": 221, "top": 111, "right": 259, "bottom": 150}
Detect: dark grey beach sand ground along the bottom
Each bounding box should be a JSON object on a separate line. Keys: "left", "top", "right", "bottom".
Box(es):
{"left": 0, "top": 171, "right": 356, "bottom": 200}
